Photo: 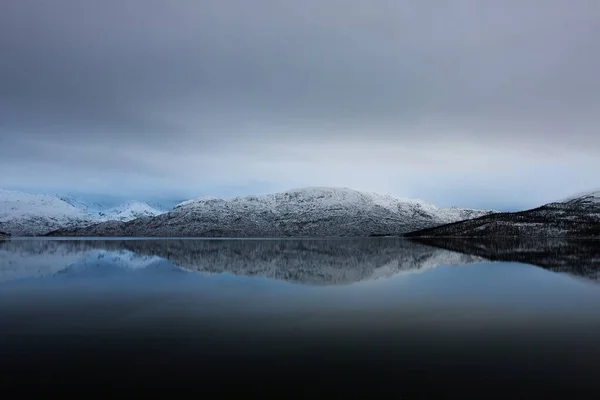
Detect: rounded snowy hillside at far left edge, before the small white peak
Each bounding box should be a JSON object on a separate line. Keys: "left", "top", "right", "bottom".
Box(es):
{"left": 0, "top": 189, "right": 95, "bottom": 236}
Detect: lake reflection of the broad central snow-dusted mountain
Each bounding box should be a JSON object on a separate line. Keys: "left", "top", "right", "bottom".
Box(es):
{"left": 71, "top": 239, "right": 482, "bottom": 285}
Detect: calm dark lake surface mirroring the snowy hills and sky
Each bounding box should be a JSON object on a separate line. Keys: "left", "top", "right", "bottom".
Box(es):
{"left": 0, "top": 239, "right": 600, "bottom": 399}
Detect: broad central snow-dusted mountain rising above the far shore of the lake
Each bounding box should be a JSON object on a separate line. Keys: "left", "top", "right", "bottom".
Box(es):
{"left": 48, "top": 187, "right": 493, "bottom": 237}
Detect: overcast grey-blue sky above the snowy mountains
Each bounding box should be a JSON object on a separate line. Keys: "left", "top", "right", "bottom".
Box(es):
{"left": 0, "top": 0, "right": 600, "bottom": 210}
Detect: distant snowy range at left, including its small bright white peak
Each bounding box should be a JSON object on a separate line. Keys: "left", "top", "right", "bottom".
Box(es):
{"left": 0, "top": 190, "right": 165, "bottom": 236}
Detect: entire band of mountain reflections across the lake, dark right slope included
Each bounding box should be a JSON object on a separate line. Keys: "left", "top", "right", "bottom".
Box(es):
{"left": 0, "top": 238, "right": 600, "bottom": 285}
